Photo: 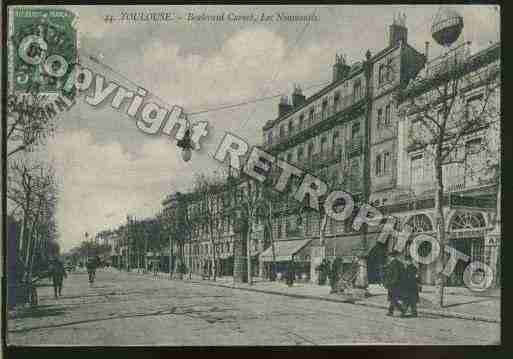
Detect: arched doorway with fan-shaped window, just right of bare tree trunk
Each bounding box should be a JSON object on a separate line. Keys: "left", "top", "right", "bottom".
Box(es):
{"left": 448, "top": 211, "right": 487, "bottom": 286}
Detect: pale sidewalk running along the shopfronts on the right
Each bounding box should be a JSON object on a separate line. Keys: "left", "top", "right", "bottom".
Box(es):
{"left": 122, "top": 270, "right": 501, "bottom": 323}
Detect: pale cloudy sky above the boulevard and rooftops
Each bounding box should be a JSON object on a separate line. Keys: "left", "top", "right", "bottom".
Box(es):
{"left": 8, "top": 5, "right": 500, "bottom": 250}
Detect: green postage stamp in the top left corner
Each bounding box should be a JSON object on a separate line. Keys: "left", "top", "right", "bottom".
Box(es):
{"left": 8, "top": 7, "right": 78, "bottom": 94}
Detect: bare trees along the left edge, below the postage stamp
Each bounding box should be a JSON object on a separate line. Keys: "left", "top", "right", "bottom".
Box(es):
{"left": 5, "top": 93, "right": 60, "bottom": 302}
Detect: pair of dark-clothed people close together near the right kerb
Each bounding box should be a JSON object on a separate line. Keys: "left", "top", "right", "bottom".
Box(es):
{"left": 383, "top": 251, "right": 421, "bottom": 317}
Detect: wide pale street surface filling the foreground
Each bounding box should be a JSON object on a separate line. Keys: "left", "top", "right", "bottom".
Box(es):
{"left": 7, "top": 271, "right": 500, "bottom": 346}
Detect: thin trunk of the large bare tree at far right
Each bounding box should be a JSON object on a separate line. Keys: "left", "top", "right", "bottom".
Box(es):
{"left": 435, "top": 158, "right": 446, "bottom": 308}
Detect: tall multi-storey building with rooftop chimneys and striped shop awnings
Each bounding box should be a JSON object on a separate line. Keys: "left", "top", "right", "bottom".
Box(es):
{"left": 263, "top": 19, "right": 425, "bottom": 284}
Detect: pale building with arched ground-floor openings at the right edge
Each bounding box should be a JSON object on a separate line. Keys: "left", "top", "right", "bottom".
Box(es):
{"left": 392, "top": 43, "right": 500, "bottom": 285}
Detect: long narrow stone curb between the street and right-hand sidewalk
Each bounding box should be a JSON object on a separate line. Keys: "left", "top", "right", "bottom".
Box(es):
{"left": 188, "top": 280, "right": 501, "bottom": 324}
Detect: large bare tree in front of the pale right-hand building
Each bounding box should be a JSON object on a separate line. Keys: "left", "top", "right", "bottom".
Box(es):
{"left": 397, "top": 41, "right": 500, "bottom": 307}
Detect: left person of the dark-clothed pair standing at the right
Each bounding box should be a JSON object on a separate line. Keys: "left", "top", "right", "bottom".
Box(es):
{"left": 383, "top": 250, "right": 405, "bottom": 317}
